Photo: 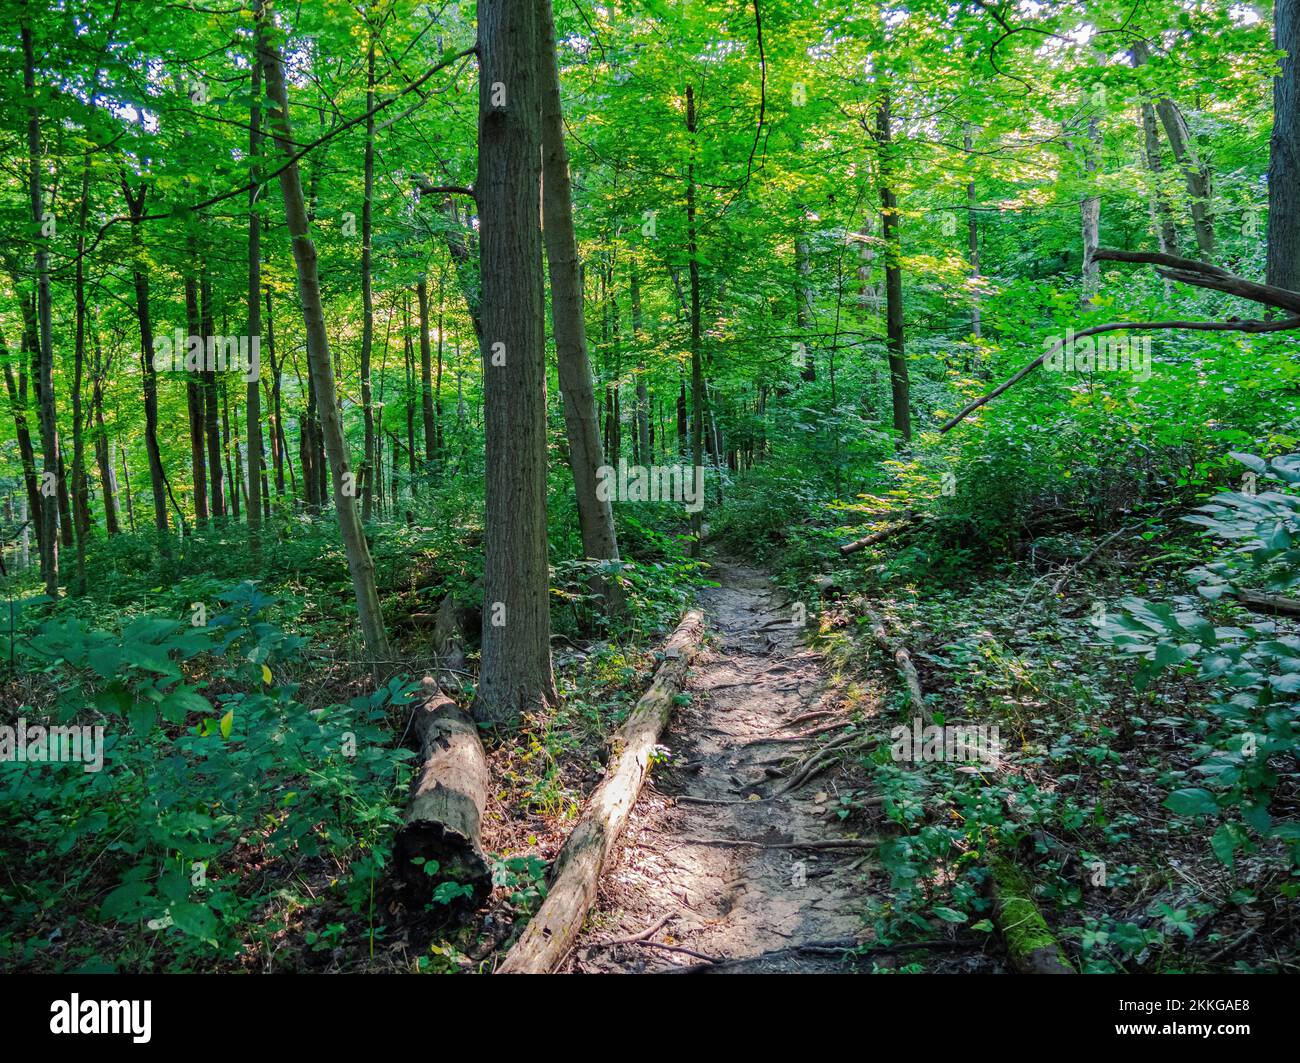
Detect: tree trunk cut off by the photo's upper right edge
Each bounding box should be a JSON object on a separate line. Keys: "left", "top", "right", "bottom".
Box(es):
{"left": 1266, "top": 0, "right": 1300, "bottom": 291}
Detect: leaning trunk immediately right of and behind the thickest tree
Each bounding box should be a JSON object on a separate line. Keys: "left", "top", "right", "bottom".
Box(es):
{"left": 537, "top": 0, "right": 621, "bottom": 608}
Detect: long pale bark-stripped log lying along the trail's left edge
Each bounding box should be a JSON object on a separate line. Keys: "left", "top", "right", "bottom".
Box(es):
{"left": 498, "top": 609, "right": 703, "bottom": 975}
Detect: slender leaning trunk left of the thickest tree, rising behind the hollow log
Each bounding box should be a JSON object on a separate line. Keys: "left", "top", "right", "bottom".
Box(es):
{"left": 259, "top": 4, "right": 389, "bottom": 659}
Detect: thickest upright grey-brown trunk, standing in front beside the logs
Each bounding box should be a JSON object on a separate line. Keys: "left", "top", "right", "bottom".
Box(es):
{"left": 475, "top": 0, "right": 556, "bottom": 723}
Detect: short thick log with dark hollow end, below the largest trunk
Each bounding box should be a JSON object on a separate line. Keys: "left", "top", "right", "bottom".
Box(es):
{"left": 394, "top": 677, "right": 491, "bottom": 911}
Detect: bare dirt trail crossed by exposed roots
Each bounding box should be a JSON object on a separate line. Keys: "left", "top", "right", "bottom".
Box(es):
{"left": 568, "top": 561, "right": 868, "bottom": 973}
